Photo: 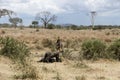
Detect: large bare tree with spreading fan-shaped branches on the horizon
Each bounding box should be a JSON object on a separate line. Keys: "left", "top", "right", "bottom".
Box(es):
{"left": 36, "top": 11, "right": 56, "bottom": 28}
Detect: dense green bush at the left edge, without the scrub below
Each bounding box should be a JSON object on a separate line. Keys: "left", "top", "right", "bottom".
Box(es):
{"left": 0, "top": 37, "right": 29, "bottom": 62}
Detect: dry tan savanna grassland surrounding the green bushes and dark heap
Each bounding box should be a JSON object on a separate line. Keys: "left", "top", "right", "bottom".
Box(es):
{"left": 0, "top": 28, "right": 120, "bottom": 80}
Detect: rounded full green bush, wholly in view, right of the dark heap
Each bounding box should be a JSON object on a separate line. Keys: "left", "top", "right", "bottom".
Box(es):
{"left": 82, "top": 39, "right": 106, "bottom": 60}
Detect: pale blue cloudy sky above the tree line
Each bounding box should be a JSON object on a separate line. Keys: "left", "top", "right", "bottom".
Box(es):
{"left": 0, "top": 0, "right": 120, "bottom": 25}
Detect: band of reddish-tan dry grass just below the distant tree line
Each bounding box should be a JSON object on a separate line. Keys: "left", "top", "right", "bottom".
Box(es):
{"left": 2, "top": 28, "right": 120, "bottom": 42}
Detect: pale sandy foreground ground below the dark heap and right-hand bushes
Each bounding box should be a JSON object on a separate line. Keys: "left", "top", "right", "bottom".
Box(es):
{"left": 33, "top": 52, "right": 120, "bottom": 80}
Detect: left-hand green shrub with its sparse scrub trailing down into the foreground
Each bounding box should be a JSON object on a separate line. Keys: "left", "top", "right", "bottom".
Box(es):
{"left": 0, "top": 37, "right": 38, "bottom": 80}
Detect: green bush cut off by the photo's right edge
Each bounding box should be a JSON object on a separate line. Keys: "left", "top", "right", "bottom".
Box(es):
{"left": 107, "top": 39, "right": 120, "bottom": 60}
